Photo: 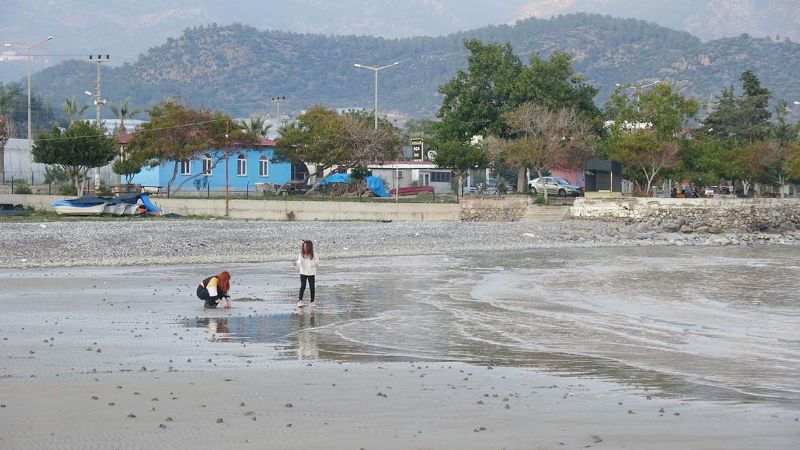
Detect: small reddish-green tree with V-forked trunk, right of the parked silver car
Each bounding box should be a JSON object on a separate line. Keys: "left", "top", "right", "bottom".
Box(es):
{"left": 612, "top": 130, "right": 679, "bottom": 196}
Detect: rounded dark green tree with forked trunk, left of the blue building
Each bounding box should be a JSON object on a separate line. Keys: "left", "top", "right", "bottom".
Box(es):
{"left": 33, "top": 120, "right": 117, "bottom": 193}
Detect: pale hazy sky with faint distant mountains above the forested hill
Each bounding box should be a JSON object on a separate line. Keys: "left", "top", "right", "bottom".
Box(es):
{"left": 0, "top": 0, "right": 800, "bottom": 81}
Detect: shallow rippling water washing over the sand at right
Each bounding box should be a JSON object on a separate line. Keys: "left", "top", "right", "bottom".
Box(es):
{"left": 183, "top": 246, "right": 800, "bottom": 405}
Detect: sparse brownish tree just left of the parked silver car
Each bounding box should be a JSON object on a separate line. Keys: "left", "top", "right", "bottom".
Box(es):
{"left": 500, "top": 102, "right": 595, "bottom": 203}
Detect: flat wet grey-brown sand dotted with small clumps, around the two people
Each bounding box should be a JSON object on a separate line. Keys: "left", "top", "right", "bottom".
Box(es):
{"left": 0, "top": 258, "right": 800, "bottom": 449}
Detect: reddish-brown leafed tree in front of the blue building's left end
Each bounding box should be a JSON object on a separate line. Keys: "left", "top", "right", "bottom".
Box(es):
{"left": 128, "top": 101, "right": 250, "bottom": 194}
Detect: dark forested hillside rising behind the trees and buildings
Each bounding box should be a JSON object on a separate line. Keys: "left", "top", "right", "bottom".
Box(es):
{"left": 28, "top": 14, "right": 800, "bottom": 117}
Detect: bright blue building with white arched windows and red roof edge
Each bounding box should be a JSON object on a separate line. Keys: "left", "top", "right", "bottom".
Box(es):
{"left": 133, "top": 139, "right": 292, "bottom": 193}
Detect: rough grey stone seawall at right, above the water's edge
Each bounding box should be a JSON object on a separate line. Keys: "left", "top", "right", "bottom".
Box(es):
{"left": 570, "top": 198, "right": 800, "bottom": 233}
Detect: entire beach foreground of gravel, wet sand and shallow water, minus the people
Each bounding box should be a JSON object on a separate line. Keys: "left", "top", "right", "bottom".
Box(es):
{"left": 0, "top": 221, "right": 800, "bottom": 449}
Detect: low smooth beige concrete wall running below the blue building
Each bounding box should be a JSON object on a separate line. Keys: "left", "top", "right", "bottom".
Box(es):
{"left": 0, "top": 195, "right": 461, "bottom": 221}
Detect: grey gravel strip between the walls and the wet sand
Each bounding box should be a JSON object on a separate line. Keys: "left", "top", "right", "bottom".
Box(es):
{"left": 0, "top": 219, "right": 800, "bottom": 268}
